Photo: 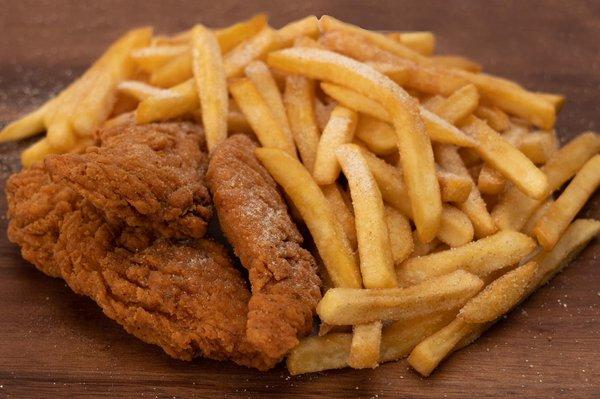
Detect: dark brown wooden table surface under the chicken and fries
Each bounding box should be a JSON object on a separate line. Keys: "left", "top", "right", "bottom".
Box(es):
{"left": 0, "top": 0, "right": 600, "bottom": 398}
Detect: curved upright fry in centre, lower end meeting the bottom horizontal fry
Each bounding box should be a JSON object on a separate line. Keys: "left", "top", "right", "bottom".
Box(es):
{"left": 338, "top": 144, "right": 397, "bottom": 288}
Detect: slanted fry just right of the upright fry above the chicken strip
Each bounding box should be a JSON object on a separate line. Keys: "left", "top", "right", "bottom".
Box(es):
{"left": 229, "top": 78, "right": 296, "bottom": 157}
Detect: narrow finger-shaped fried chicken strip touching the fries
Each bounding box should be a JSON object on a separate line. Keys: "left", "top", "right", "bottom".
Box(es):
{"left": 206, "top": 135, "right": 321, "bottom": 358}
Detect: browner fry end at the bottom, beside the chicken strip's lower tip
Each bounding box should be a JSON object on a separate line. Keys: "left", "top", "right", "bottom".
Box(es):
{"left": 286, "top": 333, "right": 352, "bottom": 375}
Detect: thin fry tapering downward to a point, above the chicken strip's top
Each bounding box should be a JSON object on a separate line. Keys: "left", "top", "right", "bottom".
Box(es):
{"left": 244, "top": 61, "right": 294, "bottom": 150}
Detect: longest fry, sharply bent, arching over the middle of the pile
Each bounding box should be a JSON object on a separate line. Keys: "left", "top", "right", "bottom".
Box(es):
{"left": 267, "top": 48, "right": 442, "bottom": 245}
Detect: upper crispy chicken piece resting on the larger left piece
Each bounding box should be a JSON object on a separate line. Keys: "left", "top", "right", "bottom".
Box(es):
{"left": 45, "top": 123, "right": 212, "bottom": 238}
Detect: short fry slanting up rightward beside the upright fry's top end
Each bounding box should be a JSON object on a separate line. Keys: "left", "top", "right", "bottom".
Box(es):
{"left": 223, "top": 26, "right": 276, "bottom": 78}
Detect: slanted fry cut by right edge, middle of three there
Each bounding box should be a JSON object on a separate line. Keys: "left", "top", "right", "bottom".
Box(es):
{"left": 533, "top": 154, "right": 600, "bottom": 250}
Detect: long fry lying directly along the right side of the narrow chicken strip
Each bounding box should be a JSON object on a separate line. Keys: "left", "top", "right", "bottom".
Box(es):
{"left": 255, "top": 148, "right": 362, "bottom": 288}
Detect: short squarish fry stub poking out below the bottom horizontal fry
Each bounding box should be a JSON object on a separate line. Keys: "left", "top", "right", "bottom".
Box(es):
{"left": 348, "top": 321, "right": 382, "bottom": 369}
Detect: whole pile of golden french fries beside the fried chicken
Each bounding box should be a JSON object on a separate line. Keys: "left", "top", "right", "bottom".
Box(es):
{"left": 0, "top": 14, "right": 600, "bottom": 376}
